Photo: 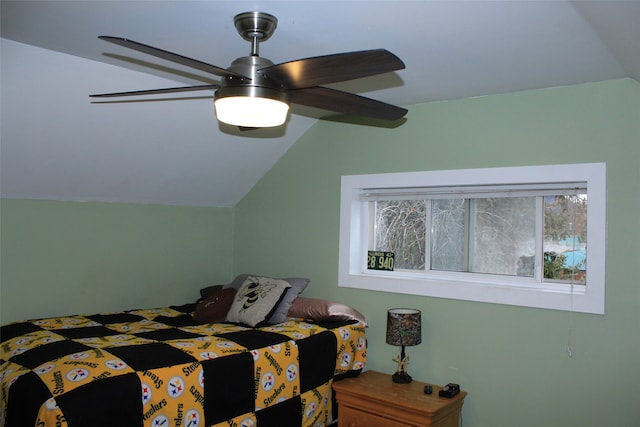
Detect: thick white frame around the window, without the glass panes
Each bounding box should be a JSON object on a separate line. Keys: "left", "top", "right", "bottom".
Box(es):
{"left": 338, "top": 163, "right": 606, "bottom": 314}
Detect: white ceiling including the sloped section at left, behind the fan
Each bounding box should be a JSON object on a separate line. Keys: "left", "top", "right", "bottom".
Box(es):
{"left": 0, "top": 0, "right": 640, "bottom": 206}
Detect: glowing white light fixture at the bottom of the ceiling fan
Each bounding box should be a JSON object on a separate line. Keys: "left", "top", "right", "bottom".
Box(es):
{"left": 214, "top": 86, "right": 289, "bottom": 128}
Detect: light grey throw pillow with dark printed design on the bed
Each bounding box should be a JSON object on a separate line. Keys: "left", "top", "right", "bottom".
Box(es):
{"left": 226, "top": 276, "right": 291, "bottom": 327}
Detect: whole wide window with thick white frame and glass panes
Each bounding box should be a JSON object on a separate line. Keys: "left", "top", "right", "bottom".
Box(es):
{"left": 339, "top": 164, "right": 606, "bottom": 314}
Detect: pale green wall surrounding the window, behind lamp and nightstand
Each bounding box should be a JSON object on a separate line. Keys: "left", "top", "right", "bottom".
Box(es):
{"left": 234, "top": 79, "right": 640, "bottom": 427}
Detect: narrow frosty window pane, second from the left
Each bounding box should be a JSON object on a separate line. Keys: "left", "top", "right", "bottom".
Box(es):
{"left": 431, "top": 199, "right": 469, "bottom": 271}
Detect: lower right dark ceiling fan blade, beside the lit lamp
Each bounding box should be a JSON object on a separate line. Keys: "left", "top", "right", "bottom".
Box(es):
{"left": 289, "top": 87, "right": 407, "bottom": 120}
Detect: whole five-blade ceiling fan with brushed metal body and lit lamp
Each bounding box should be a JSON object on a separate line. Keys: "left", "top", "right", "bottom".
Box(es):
{"left": 89, "top": 12, "right": 407, "bottom": 128}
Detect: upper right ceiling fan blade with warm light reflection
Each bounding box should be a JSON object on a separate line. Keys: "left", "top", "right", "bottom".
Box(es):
{"left": 259, "top": 49, "right": 405, "bottom": 89}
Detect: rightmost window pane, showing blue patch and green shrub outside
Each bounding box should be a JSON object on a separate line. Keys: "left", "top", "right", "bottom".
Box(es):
{"left": 543, "top": 194, "right": 587, "bottom": 284}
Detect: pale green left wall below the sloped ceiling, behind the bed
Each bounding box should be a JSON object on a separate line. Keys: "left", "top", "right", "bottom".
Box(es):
{"left": 0, "top": 199, "right": 233, "bottom": 324}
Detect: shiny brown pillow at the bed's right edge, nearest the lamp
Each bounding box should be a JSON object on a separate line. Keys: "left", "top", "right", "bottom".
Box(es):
{"left": 288, "top": 297, "right": 367, "bottom": 326}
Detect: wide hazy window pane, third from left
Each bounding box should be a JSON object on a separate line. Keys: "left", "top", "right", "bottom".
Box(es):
{"left": 469, "top": 197, "right": 536, "bottom": 276}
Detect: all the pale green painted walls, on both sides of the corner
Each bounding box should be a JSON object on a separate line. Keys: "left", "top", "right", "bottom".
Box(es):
{"left": 0, "top": 79, "right": 640, "bottom": 427}
